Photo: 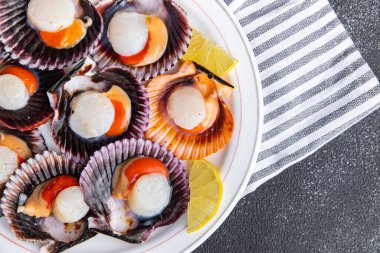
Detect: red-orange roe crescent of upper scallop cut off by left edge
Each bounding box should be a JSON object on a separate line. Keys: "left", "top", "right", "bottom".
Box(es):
{"left": 0, "top": 66, "right": 38, "bottom": 94}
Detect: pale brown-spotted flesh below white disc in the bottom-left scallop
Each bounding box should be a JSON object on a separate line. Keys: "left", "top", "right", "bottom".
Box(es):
{"left": 40, "top": 216, "right": 87, "bottom": 243}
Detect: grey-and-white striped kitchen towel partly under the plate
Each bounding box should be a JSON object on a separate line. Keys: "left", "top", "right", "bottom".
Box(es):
{"left": 224, "top": 0, "right": 380, "bottom": 196}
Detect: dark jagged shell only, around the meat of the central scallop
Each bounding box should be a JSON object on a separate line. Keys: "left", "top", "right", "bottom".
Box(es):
{"left": 49, "top": 59, "right": 150, "bottom": 164}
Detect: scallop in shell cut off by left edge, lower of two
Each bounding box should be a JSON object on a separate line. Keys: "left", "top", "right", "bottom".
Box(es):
{"left": 0, "top": 125, "right": 46, "bottom": 216}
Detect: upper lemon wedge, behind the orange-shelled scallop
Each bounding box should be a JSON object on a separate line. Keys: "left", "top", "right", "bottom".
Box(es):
{"left": 183, "top": 29, "right": 239, "bottom": 76}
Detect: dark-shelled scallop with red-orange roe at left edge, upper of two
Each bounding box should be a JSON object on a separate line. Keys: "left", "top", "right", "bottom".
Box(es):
{"left": 0, "top": 64, "right": 63, "bottom": 131}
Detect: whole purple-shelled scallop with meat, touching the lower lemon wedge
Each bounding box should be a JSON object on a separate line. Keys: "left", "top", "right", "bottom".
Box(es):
{"left": 80, "top": 139, "right": 190, "bottom": 243}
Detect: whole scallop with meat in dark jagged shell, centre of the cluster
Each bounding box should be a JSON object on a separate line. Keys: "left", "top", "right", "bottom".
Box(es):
{"left": 49, "top": 59, "right": 150, "bottom": 164}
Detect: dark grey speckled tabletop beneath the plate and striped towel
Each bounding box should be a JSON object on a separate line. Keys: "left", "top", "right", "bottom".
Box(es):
{"left": 196, "top": 0, "right": 380, "bottom": 253}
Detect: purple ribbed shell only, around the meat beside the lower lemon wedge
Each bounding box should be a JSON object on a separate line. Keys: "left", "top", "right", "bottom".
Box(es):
{"left": 80, "top": 139, "right": 190, "bottom": 243}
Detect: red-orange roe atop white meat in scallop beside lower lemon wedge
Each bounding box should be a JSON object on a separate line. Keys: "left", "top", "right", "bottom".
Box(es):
{"left": 124, "top": 157, "right": 169, "bottom": 189}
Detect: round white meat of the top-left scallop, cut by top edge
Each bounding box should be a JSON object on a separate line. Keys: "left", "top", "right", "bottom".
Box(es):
{"left": 27, "top": 0, "right": 76, "bottom": 32}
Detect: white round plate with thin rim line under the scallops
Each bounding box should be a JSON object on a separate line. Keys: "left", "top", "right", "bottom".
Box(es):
{"left": 0, "top": 0, "right": 263, "bottom": 253}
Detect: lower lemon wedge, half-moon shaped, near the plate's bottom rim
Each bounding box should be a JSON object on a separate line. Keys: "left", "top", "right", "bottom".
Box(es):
{"left": 187, "top": 160, "right": 223, "bottom": 233}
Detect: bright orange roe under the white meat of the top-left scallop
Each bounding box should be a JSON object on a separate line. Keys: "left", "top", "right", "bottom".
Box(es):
{"left": 39, "top": 19, "right": 86, "bottom": 49}
